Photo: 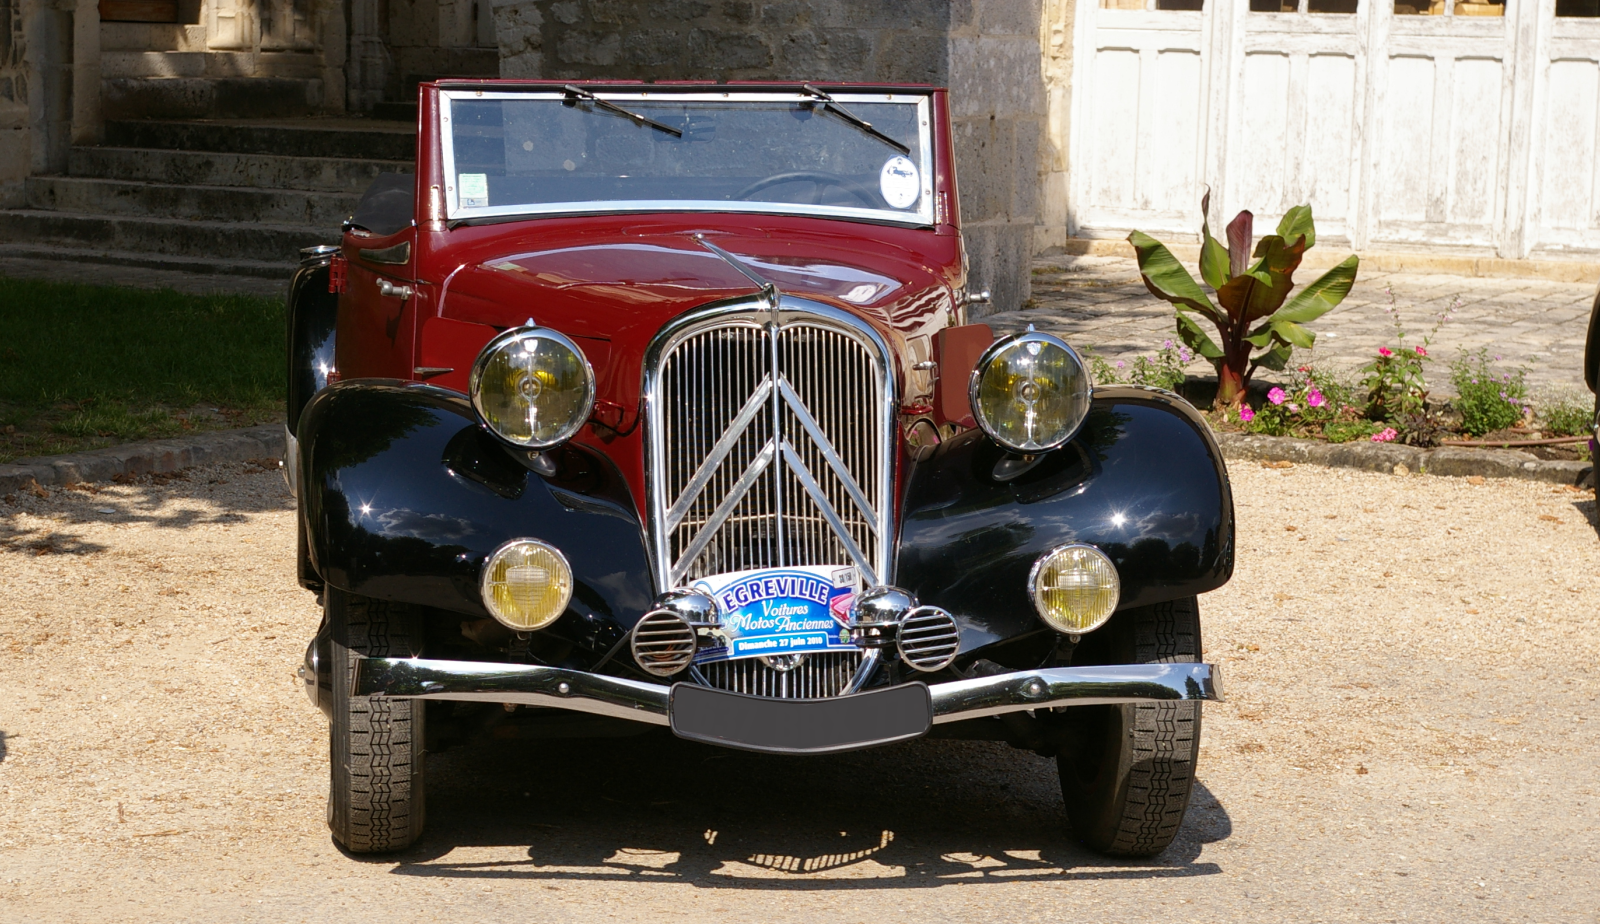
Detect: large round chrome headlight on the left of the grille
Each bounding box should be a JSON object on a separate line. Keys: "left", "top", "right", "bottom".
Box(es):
{"left": 467, "top": 326, "right": 595, "bottom": 449}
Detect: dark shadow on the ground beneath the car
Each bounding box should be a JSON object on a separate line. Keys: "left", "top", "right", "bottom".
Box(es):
{"left": 374, "top": 732, "right": 1232, "bottom": 890}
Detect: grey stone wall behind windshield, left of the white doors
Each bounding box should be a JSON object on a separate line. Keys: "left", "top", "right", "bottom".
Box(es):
{"left": 480, "top": 0, "right": 1045, "bottom": 310}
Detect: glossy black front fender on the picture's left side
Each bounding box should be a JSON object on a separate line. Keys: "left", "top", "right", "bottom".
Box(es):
{"left": 298, "top": 380, "right": 654, "bottom": 649}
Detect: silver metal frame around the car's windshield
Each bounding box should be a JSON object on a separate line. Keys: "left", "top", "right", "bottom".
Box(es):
{"left": 438, "top": 86, "right": 936, "bottom": 227}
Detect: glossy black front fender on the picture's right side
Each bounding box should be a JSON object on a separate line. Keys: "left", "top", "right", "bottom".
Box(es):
{"left": 896, "top": 387, "right": 1234, "bottom": 651}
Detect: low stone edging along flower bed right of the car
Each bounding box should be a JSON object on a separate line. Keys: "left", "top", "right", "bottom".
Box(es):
{"left": 1216, "top": 433, "right": 1594, "bottom": 486}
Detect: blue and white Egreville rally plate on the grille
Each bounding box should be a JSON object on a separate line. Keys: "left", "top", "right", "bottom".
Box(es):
{"left": 694, "top": 564, "right": 861, "bottom": 663}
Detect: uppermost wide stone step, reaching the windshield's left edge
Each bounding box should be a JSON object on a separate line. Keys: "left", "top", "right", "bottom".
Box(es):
{"left": 106, "top": 118, "right": 416, "bottom": 163}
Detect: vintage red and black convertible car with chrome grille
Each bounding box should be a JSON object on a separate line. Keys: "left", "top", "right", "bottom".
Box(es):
{"left": 288, "top": 80, "right": 1234, "bottom": 855}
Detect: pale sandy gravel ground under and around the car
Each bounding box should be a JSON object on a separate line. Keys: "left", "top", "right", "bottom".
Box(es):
{"left": 0, "top": 464, "right": 1600, "bottom": 924}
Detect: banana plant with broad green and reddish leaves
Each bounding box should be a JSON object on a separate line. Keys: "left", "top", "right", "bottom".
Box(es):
{"left": 1128, "top": 193, "right": 1360, "bottom": 408}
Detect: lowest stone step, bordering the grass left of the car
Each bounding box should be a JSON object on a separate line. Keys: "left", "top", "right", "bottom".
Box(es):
{"left": 0, "top": 208, "right": 339, "bottom": 264}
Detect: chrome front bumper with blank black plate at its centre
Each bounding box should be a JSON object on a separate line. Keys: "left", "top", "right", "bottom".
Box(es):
{"left": 352, "top": 657, "right": 1222, "bottom": 755}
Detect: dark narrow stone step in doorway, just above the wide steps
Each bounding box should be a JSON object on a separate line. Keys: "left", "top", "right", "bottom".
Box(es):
{"left": 101, "top": 77, "right": 323, "bottom": 118}
